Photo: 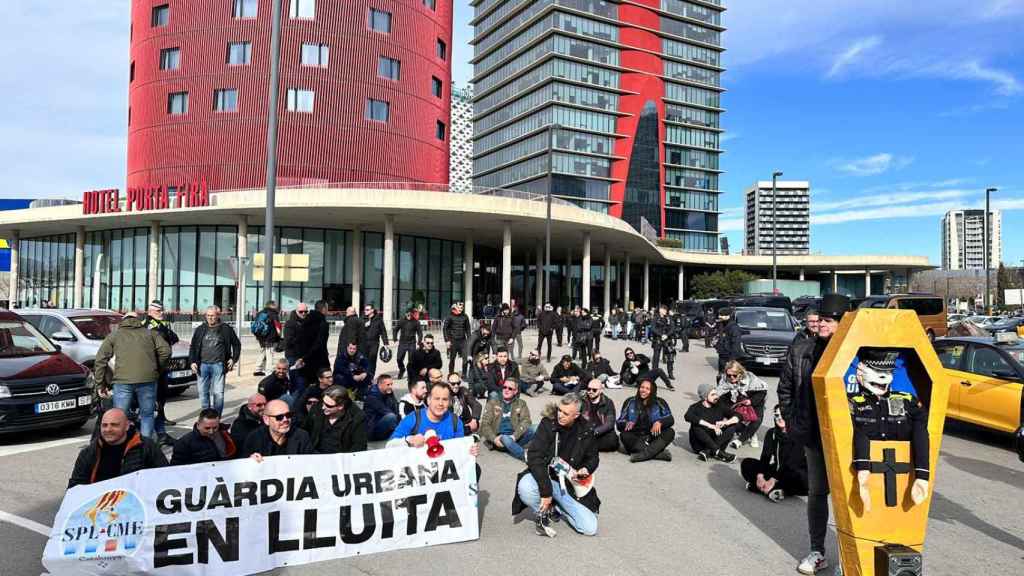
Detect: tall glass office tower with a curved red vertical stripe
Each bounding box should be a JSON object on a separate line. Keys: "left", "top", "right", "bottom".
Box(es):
{"left": 470, "top": 0, "right": 725, "bottom": 252}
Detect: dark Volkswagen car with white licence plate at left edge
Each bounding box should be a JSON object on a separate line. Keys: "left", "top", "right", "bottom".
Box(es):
{"left": 0, "top": 311, "right": 93, "bottom": 434}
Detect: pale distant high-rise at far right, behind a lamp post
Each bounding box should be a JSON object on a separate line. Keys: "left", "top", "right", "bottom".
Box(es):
{"left": 942, "top": 209, "right": 1002, "bottom": 270}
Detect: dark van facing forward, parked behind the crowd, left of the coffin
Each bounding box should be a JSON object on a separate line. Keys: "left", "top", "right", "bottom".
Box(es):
{"left": 736, "top": 306, "right": 797, "bottom": 370}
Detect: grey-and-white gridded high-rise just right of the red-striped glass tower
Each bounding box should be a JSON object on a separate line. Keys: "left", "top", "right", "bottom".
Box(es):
{"left": 744, "top": 180, "right": 811, "bottom": 255}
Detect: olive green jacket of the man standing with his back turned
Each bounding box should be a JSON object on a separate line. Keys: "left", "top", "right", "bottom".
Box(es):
{"left": 92, "top": 316, "right": 171, "bottom": 384}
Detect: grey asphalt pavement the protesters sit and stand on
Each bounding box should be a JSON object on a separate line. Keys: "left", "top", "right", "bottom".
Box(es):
{"left": 0, "top": 332, "right": 1024, "bottom": 576}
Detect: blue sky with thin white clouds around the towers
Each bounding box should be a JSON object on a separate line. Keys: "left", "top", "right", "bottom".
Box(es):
{"left": 0, "top": 0, "right": 1024, "bottom": 263}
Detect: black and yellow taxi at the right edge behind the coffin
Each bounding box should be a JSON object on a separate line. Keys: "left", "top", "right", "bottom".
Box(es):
{"left": 935, "top": 332, "right": 1024, "bottom": 458}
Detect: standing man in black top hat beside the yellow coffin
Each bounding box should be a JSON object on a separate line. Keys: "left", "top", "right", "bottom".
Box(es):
{"left": 778, "top": 294, "right": 850, "bottom": 574}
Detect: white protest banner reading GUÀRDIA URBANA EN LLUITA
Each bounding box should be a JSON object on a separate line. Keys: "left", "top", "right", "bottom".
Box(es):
{"left": 43, "top": 438, "right": 479, "bottom": 576}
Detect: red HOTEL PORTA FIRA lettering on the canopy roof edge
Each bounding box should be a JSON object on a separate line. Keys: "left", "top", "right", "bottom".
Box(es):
{"left": 82, "top": 178, "right": 210, "bottom": 215}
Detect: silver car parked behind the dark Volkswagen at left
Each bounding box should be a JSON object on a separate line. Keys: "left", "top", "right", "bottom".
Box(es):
{"left": 18, "top": 308, "right": 196, "bottom": 397}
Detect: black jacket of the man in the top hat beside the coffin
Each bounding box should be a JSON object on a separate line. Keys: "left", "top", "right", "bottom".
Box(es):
{"left": 778, "top": 338, "right": 827, "bottom": 450}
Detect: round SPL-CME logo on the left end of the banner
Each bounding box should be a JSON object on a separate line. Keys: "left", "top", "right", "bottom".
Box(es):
{"left": 60, "top": 490, "right": 145, "bottom": 560}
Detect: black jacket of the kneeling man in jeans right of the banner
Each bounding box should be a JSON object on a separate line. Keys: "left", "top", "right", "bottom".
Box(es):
{"left": 512, "top": 415, "right": 601, "bottom": 515}
